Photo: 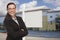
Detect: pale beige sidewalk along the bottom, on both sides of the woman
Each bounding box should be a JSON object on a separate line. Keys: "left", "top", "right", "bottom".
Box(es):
{"left": 0, "top": 33, "right": 60, "bottom": 40}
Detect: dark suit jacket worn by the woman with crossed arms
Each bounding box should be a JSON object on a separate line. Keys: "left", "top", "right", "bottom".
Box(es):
{"left": 4, "top": 14, "right": 28, "bottom": 40}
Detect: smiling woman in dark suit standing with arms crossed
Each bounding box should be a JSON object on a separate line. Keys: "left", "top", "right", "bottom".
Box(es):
{"left": 4, "top": 3, "right": 28, "bottom": 40}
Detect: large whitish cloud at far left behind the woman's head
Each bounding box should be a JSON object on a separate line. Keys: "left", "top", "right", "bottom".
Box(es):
{"left": 0, "top": 0, "right": 19, "bottom": 15}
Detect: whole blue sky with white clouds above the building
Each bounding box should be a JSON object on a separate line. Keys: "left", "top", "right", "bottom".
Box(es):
{"left": 0, "top": 0, "right": 60, "bottom": 23}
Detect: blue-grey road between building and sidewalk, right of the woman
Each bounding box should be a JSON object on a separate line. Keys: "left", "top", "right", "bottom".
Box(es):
{"left": 28, "top": 30, "right": 60, "bottom": 38}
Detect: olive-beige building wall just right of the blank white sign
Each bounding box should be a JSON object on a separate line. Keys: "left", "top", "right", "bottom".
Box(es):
{"left": 39, "top": 13, "right": 56, "bottom": 31}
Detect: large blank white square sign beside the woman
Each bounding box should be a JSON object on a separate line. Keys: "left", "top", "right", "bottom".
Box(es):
{"left": 24, "top": 11, "right": 42, "bottom": 27}
